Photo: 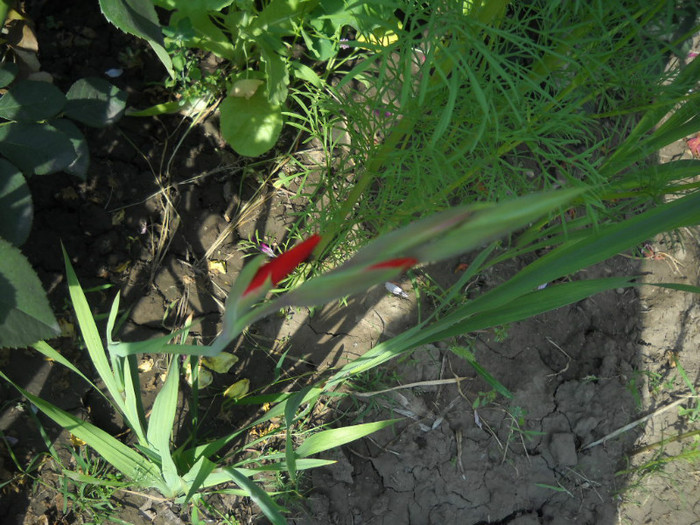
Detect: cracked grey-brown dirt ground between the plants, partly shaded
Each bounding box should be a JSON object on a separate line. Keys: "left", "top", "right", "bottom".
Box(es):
{"left": 0, "top": 2, "right": 700, "bottom": 525}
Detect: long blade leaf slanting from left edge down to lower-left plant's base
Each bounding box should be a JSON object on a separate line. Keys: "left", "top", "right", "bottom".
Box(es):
{"left": 0, "top": 366, "right": 164, "bottom": 490}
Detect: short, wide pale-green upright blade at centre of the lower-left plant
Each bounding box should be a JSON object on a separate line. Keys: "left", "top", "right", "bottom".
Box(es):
{"left": 147, "top": 356, "right": 183, "bottom": 497}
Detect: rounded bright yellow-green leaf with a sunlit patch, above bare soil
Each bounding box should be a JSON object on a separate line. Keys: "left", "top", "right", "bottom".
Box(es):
{"left": 219, "top": 89, "right": 282, "bottom": 157}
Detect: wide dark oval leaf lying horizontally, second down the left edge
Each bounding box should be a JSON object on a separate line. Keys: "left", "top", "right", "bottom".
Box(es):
{"left": 0, "top": 122, "right": 75, "bottom": 175}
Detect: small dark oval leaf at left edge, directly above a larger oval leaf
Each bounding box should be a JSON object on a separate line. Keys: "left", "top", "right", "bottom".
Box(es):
{"left": 0, "top": 80, "right": 66, "bottom": 122}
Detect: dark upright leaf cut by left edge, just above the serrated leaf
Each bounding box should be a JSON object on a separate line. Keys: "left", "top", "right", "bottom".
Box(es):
{"left": 0, "top": 159, "right": 34, "bottom": 246}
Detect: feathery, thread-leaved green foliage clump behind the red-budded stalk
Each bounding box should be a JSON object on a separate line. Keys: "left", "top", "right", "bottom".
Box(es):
{"left": 284, "top": 0, "right": 697, "bottom": 258}
